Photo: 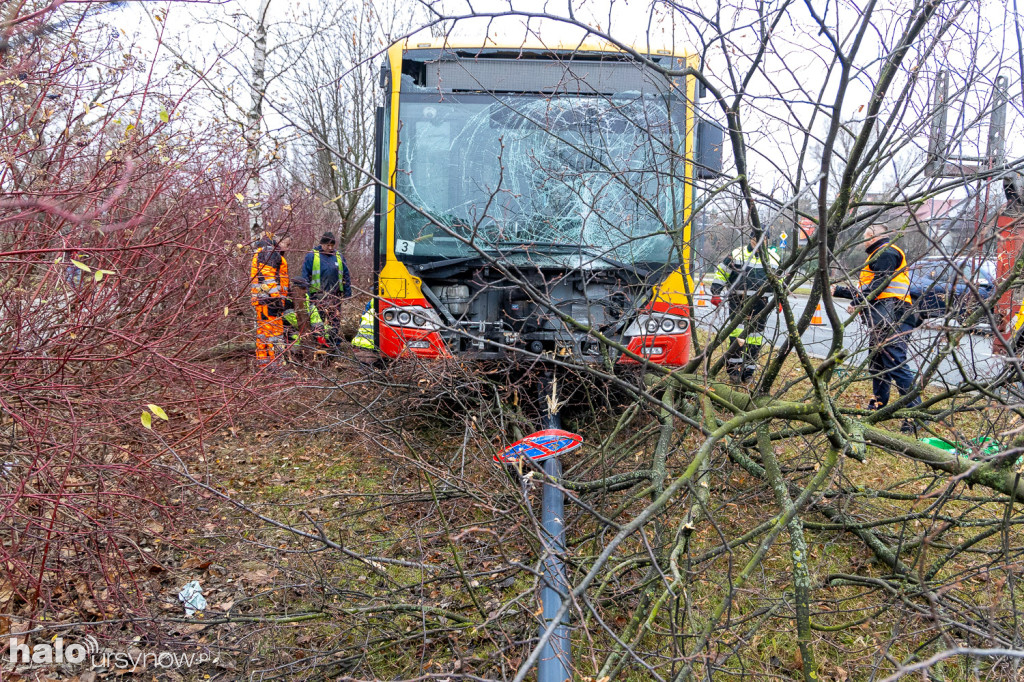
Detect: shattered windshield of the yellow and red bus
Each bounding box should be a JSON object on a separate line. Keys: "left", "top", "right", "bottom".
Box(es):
{"left": 395, "top": 92, "right": 684, "bottom": 263}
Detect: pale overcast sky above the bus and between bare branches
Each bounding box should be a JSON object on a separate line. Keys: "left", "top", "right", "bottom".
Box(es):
{"left": 103, "top": 0, "right": 1024, "bottom": 215}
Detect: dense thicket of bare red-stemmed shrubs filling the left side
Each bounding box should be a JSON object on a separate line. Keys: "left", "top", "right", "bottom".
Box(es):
{"left": 0, "top": 3, "right": 272, "bottom": 630}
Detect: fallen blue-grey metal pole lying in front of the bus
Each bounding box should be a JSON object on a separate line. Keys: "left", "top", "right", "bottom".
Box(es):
{"left": 537, "top": 382, "right": 572, "bottom": 682}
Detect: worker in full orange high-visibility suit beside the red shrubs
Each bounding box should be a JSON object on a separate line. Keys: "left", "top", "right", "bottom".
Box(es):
{"left": 249, "top": 232, "right": 291, "bottom": 367}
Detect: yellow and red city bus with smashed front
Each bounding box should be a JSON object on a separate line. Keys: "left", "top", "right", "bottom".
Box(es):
{"left": 374, "top": 39, "right": 722, "bottom": 365}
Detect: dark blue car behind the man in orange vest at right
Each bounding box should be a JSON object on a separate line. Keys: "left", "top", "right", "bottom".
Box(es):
{"left": 907, "top": 256, "right": 995, "bottom": 321}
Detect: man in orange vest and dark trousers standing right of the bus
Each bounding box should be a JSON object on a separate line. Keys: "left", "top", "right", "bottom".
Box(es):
{"left": 833, "top": 225, "right": 921, "bottom": 433}
